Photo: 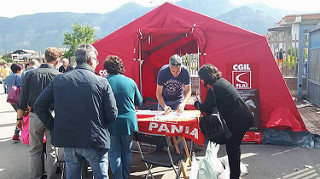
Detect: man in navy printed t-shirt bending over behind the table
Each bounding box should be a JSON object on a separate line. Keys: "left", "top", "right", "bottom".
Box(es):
{"left": 156, "top": 54, "right": 191, "bottom": 114}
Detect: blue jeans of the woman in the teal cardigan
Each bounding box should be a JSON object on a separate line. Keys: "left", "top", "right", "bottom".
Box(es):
{"left": 109, "top": 135, "right": 132, "bottom": 179}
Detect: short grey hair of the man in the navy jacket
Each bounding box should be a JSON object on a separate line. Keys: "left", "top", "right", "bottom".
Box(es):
{"left": 75, "top": 44, "right": 98, "bottom": 64}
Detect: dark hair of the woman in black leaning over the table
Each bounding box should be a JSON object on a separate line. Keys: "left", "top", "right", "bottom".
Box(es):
{"left": 198, "top": 64, "right": 222, "bottom": 86}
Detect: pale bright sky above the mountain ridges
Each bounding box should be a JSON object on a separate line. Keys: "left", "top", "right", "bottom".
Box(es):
{"left": 0, "top": 0, "right": 320, "bottom": 17}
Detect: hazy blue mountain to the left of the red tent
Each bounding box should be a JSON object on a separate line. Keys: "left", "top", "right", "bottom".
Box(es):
{"left": 0, "top": 3, "right": 152, "bottom": 54}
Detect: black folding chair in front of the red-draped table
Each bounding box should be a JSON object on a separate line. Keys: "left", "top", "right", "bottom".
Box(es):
{"left": 133, "top": 131, "right": 184, "bottom": 178}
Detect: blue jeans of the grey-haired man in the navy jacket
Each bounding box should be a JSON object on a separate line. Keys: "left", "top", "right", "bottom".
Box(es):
{"left": 64, "top": 148, "right": 109, "bottom": 179}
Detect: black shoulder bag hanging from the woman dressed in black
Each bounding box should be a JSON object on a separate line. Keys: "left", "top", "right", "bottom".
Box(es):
{"left": 199, "top": 88, "right": 232, "bottom": 144}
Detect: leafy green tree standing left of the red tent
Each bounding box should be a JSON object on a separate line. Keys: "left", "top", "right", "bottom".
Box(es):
{"left": 63, "top": 22, "right": 97, "bottom": 58}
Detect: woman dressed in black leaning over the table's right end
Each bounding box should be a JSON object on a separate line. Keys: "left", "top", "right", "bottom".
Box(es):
{"left": 194, "top": 64, "right": 254, "bottom": 179}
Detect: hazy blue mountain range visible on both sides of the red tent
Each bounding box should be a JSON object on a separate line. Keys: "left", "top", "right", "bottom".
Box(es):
{"left": 0, "top": 0, "right": 285, "bottom": 54}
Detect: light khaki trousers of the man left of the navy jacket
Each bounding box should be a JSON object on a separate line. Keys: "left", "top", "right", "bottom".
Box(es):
{"left": 29, "top": 112, "right": 57, "bottom": 179}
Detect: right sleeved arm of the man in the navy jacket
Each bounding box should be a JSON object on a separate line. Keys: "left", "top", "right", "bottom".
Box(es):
{"left": 103, "top": 80, "right": 118, "bottom": 124}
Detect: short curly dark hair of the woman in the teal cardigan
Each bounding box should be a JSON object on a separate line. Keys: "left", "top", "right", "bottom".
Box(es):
{"left": 103, "top": 55, "right": 124, "bottom": 74}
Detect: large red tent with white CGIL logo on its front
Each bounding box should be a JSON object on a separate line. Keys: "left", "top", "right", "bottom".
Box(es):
{"left": 93, "top": 3, "right": 307, "bottom": 131}
